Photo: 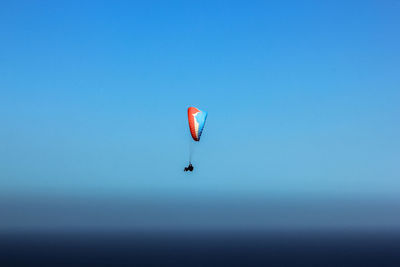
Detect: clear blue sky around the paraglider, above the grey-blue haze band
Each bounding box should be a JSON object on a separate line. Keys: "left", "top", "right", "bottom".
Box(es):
{"left": 0, "top": 0, "right": 400, "bottom": 232}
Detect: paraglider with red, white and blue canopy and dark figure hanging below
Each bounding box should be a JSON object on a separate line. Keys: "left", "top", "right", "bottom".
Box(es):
{"left": 184, "top": 107, "right": 207, "bottom": 172}
